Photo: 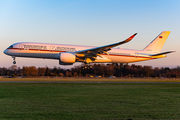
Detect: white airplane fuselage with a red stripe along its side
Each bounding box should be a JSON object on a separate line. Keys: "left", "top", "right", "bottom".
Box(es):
{"left": 4, "top": 42, "right": 165, "bottom": 63}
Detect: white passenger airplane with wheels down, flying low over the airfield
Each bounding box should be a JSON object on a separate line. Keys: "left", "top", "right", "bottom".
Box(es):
{"left": 4, "top": 31, "right": 174, "bottom": 68}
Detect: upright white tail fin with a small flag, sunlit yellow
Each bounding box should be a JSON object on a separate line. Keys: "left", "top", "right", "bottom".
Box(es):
{"left": 144, "top": 31, "right": 170, "bottom": 53}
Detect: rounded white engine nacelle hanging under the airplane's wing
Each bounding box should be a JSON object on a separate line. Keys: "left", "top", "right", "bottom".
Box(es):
{"left": 59, "top": 52, "right": 76, "bottom": 65}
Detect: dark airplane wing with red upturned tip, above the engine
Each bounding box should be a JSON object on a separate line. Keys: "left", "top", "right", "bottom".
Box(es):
{"left": 75, "top": 33, "right": 137, "bottom": 61}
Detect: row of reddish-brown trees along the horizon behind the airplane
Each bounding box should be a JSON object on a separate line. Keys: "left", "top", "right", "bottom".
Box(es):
{"left": 0, "top": 63, "right": 180, "bottom": 78}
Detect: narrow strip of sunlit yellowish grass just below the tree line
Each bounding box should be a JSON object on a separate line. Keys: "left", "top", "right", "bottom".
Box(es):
{"left": 0, "top": 78, "right": 180, "bottom": 83}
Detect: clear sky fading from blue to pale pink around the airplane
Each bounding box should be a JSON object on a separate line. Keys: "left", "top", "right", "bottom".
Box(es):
{"left": 0, "top": 0, "right": 180, "bottom": 68}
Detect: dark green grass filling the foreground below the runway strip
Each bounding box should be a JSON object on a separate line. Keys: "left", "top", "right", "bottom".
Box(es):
{"left": 0, "top": 83, "right": 180, "bottom": 120}
